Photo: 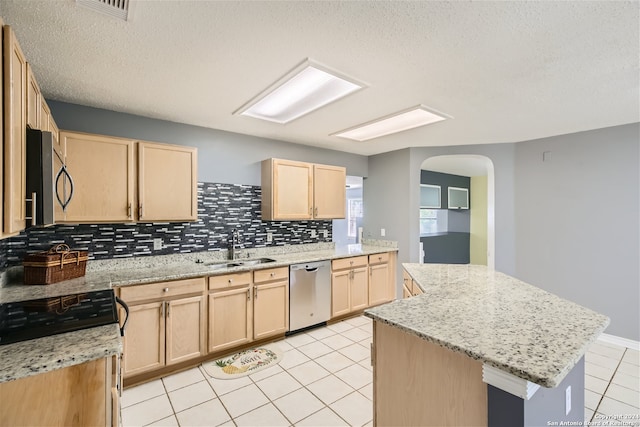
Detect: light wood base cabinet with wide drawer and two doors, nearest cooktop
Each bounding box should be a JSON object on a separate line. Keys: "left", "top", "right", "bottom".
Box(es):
{"left": 119, "top": 278, "right": 207, "bottom": 377}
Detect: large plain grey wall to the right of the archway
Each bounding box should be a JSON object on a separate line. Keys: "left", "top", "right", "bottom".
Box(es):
{"left": 516, "top": 123, "right": 640, "bottom": 341}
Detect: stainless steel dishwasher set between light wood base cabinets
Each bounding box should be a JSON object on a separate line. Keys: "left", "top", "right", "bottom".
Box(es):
{"left": 289, "top": 261, "right": 331, "bottom": 332}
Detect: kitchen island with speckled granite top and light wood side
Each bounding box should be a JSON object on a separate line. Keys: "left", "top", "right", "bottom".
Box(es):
{"left": 365, "top": 264, "right": 609, "bottom": 427}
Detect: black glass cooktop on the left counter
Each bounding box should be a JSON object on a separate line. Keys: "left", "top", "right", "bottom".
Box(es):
{"left": 0, "top": 289, "right": 118, "bottom": 345}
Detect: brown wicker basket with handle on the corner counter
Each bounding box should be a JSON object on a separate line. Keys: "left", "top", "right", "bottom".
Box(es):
{"left": 22, "top": 244, "right": 88, "bottom": 285}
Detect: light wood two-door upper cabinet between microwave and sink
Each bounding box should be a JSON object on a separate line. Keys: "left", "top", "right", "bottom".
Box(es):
{"left": 56, "top": 131, "right": 198, "bottom": 223}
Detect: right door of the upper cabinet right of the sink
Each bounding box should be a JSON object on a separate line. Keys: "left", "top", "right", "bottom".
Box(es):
{"left": 313, "top": 165, "right": 347, "bottom": 219}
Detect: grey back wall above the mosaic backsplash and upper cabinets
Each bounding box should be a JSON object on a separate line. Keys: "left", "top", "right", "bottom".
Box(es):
{"left": 47, "top": 100, "right": 368, "bottom": 185}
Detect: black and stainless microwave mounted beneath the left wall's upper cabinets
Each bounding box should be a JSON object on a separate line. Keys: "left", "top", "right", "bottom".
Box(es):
{"left": 26, "top": 129, "right": 73, "bottom": 226}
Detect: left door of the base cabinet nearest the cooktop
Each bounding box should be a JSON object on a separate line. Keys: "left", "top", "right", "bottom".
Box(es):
{"left": 122, "top": 301, "right": 165, "bottom": 376}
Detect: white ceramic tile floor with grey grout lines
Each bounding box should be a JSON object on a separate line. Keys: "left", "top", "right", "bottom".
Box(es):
{"left": 121, "top": 317, "right": 640, "bottom": 427}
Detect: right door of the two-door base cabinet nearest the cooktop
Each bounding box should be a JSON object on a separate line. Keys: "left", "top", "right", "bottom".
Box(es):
{"left": 165, "top": 295, "right": 207, "bottom": 365}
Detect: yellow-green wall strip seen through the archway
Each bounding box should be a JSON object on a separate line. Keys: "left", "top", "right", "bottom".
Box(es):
{"left": 469, "top": 176, "right": 488, "bottom": 265}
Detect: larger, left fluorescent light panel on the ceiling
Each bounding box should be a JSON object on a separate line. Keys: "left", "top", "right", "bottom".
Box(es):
{"left": 234, "top": 60, "right": 365, "bottom": 124}
